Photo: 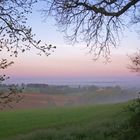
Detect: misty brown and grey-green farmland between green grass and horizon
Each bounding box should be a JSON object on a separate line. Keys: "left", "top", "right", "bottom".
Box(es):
{"left": 0, "top": 84, "right": 139, "bottom": 108}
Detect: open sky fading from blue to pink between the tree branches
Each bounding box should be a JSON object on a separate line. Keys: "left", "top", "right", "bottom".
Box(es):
{"left": 1, "top": 1, "right": 140, "bottom": 83}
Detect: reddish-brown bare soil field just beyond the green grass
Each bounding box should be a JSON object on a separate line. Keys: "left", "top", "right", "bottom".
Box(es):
{"left": 8, "top": 93, "right": 80, "bottom": 109}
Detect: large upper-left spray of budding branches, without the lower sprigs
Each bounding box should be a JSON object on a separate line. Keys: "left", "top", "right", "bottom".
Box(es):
{"left": 0, "top": 0, "right": 55, "bottom": 56}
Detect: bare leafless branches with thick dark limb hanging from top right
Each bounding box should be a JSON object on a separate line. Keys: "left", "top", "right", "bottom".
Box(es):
{"left": 43, "top": 0, "right": 140, "bottom": 59}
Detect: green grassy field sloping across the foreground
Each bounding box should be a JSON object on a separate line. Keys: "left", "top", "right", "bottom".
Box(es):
{"left": 0, "top": 103, "right": 129, "bottom": 140}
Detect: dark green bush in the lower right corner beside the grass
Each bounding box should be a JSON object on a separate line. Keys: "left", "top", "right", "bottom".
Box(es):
{"left": 109, "top": 98, "right": 140, "bottom": 140}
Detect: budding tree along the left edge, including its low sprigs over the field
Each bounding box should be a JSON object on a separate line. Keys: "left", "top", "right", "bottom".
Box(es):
{"left": 0, "top": 0, "right": 56, "bottom": 108}
